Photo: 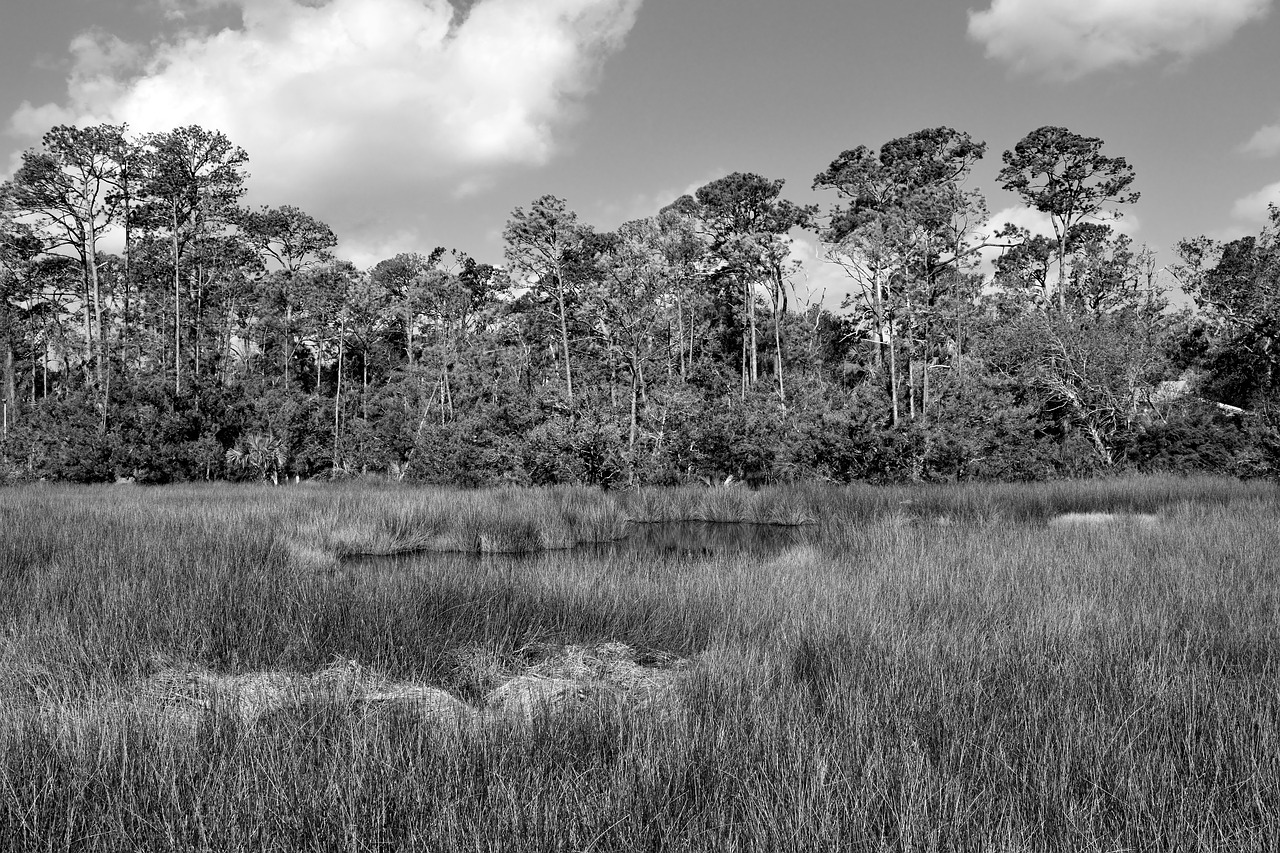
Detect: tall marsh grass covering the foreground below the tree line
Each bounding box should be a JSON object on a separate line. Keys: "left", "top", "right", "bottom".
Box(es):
{"left": 0, "top": 479, "right": 1280, "bottom": 852}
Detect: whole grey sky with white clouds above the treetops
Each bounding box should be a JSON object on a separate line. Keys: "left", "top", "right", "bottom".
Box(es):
{"left": 0, "top": 0, "right": 1280, "bottom": 302}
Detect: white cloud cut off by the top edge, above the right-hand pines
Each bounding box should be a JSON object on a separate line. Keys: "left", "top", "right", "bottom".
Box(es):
{"left": 969, "top": 0, "right": 1271, "bottom": 81}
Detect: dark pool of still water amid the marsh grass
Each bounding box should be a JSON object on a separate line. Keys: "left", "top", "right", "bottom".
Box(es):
{"left": 344, "top": 521, "right": 818, "bottom": 569}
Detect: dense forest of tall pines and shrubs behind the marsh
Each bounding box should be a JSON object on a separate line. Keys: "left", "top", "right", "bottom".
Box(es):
{"left": 0, "top": 126, "right": 1280, "bottom": 485}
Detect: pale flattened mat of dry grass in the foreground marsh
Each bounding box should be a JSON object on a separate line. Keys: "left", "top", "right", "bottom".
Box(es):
{"left": 9, "top": 643, "right": 689, "bottom": 743}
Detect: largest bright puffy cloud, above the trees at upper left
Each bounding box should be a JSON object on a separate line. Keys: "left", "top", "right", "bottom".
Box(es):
{"left": 10, "top": 0, "right": 641, "bottom": 252}
